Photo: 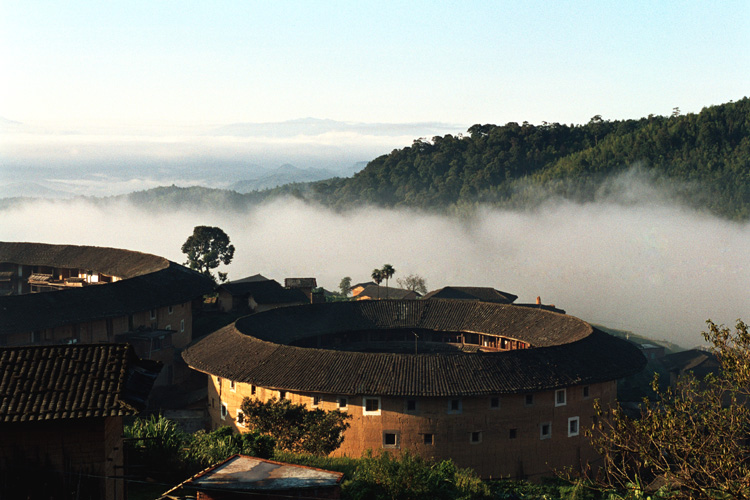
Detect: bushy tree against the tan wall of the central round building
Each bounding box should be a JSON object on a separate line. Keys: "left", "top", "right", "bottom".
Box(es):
{"left": 242, "top": 398, "right": 351, "bottom": 455}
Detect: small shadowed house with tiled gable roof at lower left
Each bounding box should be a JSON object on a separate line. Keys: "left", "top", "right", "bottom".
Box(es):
{"left": 0, "top": 344, "right": 161, "bottom": 499}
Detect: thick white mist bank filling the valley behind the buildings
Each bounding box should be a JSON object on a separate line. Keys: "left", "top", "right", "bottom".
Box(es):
{"left": 0, "top": 186, "right": 750, "bottom": 347}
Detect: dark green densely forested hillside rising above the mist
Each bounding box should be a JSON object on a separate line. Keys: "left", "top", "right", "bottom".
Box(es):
{"left": 314, "top": 98, "right": 750, "bottom": 219}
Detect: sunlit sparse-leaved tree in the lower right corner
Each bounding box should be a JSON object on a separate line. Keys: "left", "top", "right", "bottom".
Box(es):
{"left": 592, "top": 320, "right": 750, "bottom": 500}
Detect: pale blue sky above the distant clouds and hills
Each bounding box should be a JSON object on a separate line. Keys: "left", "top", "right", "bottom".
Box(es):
{"left": 0, "top": 0, "right": 750, "bottom": 127}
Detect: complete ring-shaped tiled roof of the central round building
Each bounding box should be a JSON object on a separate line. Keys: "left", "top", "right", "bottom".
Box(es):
{"left": 183, "top": 299, "right": 646, "bottom": 396}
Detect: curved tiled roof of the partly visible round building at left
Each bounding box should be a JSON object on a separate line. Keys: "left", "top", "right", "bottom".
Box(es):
{"left": 0, "top": 242, "right": 214, "bottom": 334}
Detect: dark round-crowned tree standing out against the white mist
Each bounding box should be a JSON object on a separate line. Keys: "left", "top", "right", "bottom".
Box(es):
{"left": 182, "top": 226, "right": 234, "bottom": 282}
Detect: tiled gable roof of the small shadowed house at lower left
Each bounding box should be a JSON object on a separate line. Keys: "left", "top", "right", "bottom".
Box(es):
{"left": 0, "top": 344, "right": 160, "bottom": 423}
